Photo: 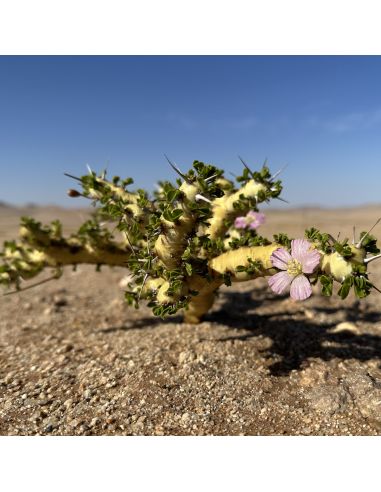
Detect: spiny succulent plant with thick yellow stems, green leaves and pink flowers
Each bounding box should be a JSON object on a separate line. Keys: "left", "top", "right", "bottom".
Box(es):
{"left": 0, "top": 161, "right": 380, "bottom": 323}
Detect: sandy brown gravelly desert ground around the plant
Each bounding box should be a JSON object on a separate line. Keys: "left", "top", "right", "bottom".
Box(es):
{"left": 0, "top": 206, "right": 381, "bottom": 436}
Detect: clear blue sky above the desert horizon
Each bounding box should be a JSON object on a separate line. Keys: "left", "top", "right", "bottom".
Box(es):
{"left": 0, "top": 56, "right": 381, "bottom": 206}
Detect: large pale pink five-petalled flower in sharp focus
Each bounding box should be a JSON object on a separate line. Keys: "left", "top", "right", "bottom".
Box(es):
{"left": 269, "top": 239, "right": 320, "bottom": 301}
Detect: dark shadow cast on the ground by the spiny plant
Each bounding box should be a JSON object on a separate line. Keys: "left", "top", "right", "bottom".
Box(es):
{"left": 205, "top": 291, "right": 381, "bottom": 376}
